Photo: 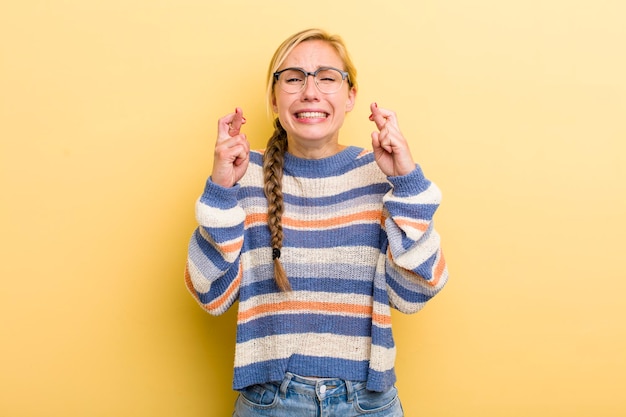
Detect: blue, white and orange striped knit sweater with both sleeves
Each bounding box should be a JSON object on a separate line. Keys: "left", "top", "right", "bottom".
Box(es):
{"left": 185, "top": 147, "right": 448, "bottom": 391}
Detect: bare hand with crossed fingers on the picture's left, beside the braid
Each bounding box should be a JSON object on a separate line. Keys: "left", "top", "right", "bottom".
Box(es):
{"left": 211, "top": 107, "right": 250, "bottom": 187}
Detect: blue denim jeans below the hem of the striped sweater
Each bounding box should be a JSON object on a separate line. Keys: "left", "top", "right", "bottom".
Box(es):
{"left": 233, "top": 372, "right": 404, "bottom": 417}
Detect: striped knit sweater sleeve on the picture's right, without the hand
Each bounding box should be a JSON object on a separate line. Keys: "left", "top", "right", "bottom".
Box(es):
{"left": 383, "top": 166, "right": 448, "bottom": 313}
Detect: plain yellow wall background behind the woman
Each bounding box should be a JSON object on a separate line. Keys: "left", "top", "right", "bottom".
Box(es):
{"left": 0, "top": 0, "right": 626, "bottom": 417}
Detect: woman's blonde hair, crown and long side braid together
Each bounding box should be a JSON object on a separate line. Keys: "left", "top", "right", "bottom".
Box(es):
{"left": 263, "top": 29, "right": 357, "bottom": 291}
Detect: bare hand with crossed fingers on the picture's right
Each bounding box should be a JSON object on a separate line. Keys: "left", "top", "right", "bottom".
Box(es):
{"left": 369, "top": 103, "right": 415, "bottom": 177}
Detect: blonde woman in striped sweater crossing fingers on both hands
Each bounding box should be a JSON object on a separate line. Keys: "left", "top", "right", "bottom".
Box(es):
{"left": 186, "top": 29, "right": 448, "bottom": 417}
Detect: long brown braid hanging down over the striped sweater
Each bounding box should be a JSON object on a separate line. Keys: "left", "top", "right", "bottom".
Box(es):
{"left": 263, "top": 118, "right": 291, "bottom": 291}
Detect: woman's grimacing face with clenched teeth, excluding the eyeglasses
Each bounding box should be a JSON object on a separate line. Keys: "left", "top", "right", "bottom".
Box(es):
{"left": 272, "top": 40, "right": 356, "bottom": 148}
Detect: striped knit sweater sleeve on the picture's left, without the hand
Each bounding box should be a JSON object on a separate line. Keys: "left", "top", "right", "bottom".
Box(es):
{"left": 185, "top": 179, "right": 245, "bottom": 315}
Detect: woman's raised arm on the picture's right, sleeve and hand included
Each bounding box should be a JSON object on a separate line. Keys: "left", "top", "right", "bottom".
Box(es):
{"left": 370, "top": 103, "right": 448, "bottom": 313}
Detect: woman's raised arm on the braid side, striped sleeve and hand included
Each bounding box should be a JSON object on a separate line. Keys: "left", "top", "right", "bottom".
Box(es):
{"left": 185, "top": 108, "right": 250, "bottom": 314}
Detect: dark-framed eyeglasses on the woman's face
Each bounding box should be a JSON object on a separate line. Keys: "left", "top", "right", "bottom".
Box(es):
{"left": 274, "top": 67, "right": 350, "bottom": 94}
